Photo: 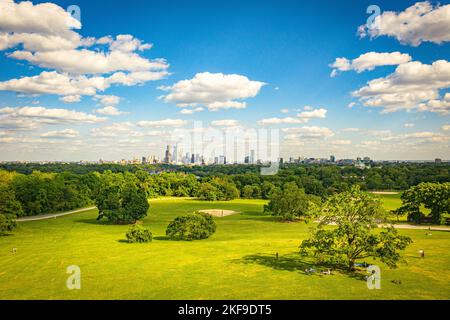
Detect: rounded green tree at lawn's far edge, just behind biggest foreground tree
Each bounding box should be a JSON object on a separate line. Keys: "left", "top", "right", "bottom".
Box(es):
{"left": 264, "top": 182, "right": 320, "bottom": 221}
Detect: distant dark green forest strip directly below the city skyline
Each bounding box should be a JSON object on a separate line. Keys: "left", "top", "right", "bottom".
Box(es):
{"left": 0, "top": 163, "right": 450, "bottom": 192}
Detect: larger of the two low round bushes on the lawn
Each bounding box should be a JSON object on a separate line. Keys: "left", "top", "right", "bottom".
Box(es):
{"left": 166, "top": 212, "right": 216, "bottom": 241}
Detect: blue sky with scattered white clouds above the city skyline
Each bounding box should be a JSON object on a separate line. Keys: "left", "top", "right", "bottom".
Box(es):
{"left": 0, "top": 0, "right": 450, "bottom": 161}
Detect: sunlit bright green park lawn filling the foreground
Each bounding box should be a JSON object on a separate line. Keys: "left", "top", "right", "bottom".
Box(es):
{"left": 0, "top": 199, "right": 450, "bottom": 299}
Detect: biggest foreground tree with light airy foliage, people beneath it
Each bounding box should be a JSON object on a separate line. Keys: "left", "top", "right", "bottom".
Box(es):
{"left": 300, "top": 186, "right": 411, "bottom": 270}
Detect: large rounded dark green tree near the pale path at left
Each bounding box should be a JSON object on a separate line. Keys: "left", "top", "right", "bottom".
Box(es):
{"left": 95, "top": 182, "right": 150, "bottom": 224}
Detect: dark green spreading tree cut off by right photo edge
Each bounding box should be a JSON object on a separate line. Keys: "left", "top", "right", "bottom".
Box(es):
{"left": 396, "top": 182, "right": 450, "bottom": 224}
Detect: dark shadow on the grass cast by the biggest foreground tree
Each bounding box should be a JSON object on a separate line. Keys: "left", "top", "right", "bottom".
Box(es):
{"left": 233, "top": 253, "right": 366, "bottom": 281}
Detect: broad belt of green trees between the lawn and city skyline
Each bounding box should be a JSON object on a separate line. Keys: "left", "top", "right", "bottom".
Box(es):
{"left": 0, "top": 164, "right": 450, "bottom": 229}
